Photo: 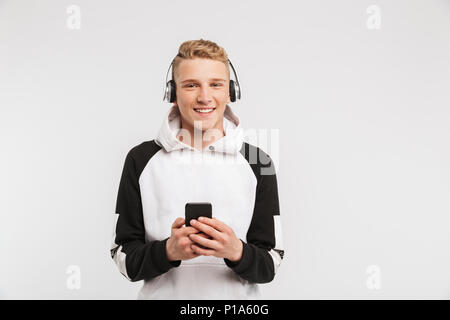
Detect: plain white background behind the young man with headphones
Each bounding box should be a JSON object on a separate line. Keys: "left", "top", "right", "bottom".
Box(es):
{"left": 0, "top": 0, "right": 450, "bottom": 299}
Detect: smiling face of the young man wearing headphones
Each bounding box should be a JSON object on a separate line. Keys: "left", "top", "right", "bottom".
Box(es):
{"left": 174, "top": 58, "right": 230, "bottom": 133}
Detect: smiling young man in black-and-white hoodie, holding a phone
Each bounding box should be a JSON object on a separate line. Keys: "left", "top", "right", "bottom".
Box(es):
{"left": 111, "top": 39, "right": 284, "bottom": 299}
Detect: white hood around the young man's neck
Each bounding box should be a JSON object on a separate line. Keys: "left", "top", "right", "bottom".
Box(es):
{"left": 155, "top": 105, "right": 244, "bottom": 154}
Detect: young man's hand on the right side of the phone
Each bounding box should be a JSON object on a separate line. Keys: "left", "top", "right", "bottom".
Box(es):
{"left": 189, "top": 217, "right": 243, "bottom": 262}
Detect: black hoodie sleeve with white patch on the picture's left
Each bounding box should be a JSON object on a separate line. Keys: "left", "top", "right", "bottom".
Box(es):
{"left": 111, "top": 143, "right": 181, "bottom": 281}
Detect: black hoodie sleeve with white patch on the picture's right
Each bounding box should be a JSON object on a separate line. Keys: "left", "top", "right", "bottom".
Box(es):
{"left": 224, "top": 143, "right": 284, "bottom": 283}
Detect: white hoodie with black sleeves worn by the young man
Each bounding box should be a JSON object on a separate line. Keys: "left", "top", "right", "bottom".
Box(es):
{"left": 111, "top": 105, "right": 284, "bottom": 300}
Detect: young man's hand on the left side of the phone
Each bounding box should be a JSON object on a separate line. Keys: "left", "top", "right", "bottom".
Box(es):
{"left": 166, "top": 218, "right": 207, "bottom": 261}
